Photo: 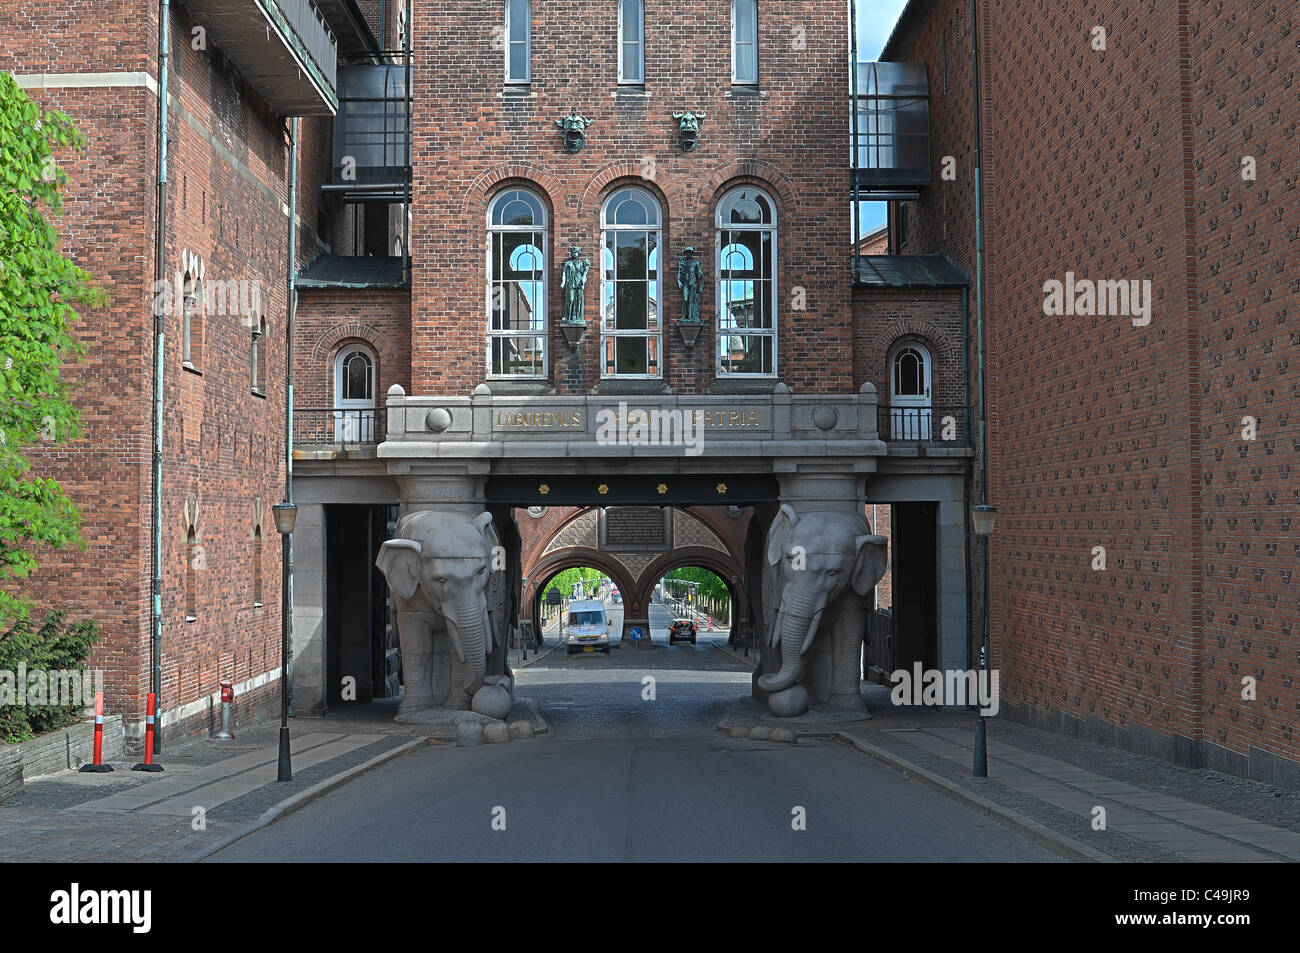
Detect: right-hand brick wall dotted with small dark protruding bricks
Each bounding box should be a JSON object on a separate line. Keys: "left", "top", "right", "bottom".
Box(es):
{"left": 896, "top": 0, "right": 1300, "bottom": 780}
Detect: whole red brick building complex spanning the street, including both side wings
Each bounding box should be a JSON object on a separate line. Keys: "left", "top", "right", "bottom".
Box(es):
{"left": 0, "top": 0, "right": 1300, "bottom": 785}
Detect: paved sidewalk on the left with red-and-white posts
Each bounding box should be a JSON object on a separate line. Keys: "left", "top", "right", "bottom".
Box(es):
{"left": 0, "top": 705, "right": 426, "bottom": 863}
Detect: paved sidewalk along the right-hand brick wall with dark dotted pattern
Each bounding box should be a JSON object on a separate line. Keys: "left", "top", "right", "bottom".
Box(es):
{"left": 723, "top": 685, "right": 1300, "bottom": 863}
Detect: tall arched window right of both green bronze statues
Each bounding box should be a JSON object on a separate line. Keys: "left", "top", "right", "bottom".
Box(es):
{"left": 716, "top": 186, "right": 777, "bottom": 377}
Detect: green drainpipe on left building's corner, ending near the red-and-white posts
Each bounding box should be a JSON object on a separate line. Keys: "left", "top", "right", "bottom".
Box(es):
{"left": 150, "top": 0, "right": 171, "bottom": 754}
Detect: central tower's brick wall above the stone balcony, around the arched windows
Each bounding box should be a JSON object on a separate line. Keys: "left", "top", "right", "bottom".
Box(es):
{"left": 412, "top": 0, "right": 852, "bottom": 394}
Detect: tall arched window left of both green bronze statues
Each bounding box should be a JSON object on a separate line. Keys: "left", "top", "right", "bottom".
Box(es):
{"left": 488, "top": 189, "right": 547, "bottom": 378}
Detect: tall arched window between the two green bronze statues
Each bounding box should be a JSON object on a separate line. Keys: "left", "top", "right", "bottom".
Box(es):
{"left": 601, "top": 186, "right": 663, "bottom": 377}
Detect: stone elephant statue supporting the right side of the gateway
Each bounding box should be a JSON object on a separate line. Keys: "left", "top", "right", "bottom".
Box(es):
{"left": 757, "top": 504, "right": 888, "bottom": 716}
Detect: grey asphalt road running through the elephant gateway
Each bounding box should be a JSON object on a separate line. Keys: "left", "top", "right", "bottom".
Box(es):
{"left": 211, "top": 595, "right": 1056, "bottom": 863}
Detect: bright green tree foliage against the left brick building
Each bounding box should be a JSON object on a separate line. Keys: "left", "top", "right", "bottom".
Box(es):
{"left": 0, "top": 73, "right": 105, "bottom": 620}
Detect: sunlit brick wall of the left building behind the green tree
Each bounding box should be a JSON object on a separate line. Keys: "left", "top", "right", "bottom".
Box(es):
{"left": 0, "top": 3, "right": 287, "bottom": 732}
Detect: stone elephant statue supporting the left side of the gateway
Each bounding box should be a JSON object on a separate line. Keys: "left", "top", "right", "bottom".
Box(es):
{"left": 374, "top": 510, "right": 507, "bottom": 720}
